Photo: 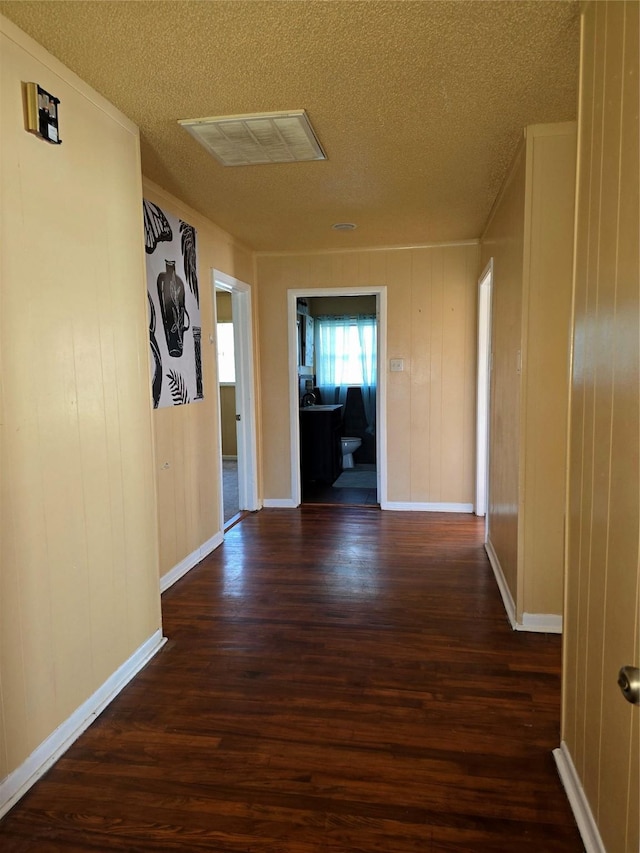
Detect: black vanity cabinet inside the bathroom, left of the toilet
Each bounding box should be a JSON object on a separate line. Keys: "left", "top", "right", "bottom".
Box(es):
{"left": 300, "top": 405, "right": 342, "bottom": 485}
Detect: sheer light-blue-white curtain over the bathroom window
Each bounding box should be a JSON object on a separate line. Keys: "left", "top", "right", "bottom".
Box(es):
{"left": 315, "top": 314, "right": 377, "bottom": 433}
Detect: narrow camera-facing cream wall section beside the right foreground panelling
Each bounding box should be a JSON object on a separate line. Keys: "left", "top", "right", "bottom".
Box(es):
{"left": 518, "top": 122, "right": 577, "bottom": 617}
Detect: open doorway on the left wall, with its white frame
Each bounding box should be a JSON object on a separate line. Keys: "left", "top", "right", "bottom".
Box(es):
{"left": 213, "top": 270, "right": 259, "bottom": 530}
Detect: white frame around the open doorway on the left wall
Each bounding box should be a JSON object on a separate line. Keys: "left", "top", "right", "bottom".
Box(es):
{"left": 212, "top": 269, "right": 260, "bottom": 530}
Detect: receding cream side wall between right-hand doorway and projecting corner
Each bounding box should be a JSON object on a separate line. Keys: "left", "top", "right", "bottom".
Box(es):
{"left": 481, "top": 145, "right": 526, "bottom": 601}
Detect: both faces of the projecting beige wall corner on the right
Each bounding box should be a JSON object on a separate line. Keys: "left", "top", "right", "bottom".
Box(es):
{"left": 482, "top": 122, "right": 576, "bottom": 626}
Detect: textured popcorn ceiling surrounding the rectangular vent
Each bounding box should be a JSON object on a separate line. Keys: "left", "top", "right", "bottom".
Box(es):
{"left": 0, "top": 0, "right": 579, "bottom": 250}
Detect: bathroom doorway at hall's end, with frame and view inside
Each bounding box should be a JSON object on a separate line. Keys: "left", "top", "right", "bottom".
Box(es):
{"left": 289, "top": 288, "right": 386, "bottom": 506}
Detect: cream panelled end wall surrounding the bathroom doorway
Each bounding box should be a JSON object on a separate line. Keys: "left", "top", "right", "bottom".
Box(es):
{"left": 257, "top": 244, "right": 478, "bottom": 503}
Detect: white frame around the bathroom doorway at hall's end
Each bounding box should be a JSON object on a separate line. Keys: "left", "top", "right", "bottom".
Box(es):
{"left": 287, "top": 285, "right": 387, "bottom": 509}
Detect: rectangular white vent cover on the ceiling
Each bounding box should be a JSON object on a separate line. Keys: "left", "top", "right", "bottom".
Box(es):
{"left": 178, "top": 110, "right": 327, "bottom": 166}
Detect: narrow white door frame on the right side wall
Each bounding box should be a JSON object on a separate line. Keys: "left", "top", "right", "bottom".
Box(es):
{"left": 475, "top": 258, "right": 493, "bottom": 524}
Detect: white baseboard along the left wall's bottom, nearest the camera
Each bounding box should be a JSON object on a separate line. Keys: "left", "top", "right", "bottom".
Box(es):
{"left": 0, "top": 629, "right": 167, "bottom": 818}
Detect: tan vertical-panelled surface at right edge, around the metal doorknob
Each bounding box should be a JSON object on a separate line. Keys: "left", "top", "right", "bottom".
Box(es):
{"left": 562, "top": 3, "right": 640, "bottom": 853}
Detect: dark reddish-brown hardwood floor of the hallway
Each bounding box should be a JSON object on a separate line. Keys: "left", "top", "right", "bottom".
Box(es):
{"left": 0, "top": 506, "right": 583, "bottom": 853}
